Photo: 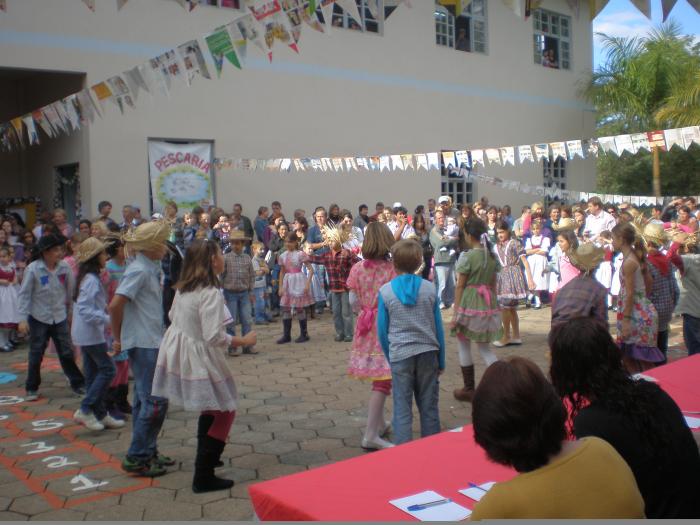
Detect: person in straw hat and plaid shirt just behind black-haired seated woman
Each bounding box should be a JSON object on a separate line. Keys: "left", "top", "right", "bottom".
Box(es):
{"left": 552, "top": 242, "right": 608, "bottom": 330}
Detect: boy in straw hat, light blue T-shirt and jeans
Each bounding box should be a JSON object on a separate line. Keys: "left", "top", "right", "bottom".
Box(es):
{"left": 109, "top": 221, "right": 175, "bottom": 477}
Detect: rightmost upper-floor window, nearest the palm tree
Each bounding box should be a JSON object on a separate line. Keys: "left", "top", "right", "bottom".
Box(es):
{"left": 532, "top": 9, "right": 571, "bottom": 69}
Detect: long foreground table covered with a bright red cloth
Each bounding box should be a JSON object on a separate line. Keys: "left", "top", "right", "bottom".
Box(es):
{"left": 249, "top": 355, "right": 700, "bottom": 521}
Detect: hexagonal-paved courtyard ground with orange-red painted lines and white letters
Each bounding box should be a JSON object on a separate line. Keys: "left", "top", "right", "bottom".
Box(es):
{"left": 0, "top": 309, "right": 685, "bottom": 521}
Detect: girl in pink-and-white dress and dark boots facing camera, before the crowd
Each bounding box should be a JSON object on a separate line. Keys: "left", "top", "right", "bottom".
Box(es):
{"left": 277, "top": 232, "right": 314, "bottom": 345}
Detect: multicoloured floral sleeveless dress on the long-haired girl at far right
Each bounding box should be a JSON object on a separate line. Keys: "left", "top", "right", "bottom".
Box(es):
{"left": 617, "top": 262, "right": 664, "bottom": 370}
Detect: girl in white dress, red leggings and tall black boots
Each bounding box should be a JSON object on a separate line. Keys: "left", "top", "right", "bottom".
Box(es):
{"left": 153, "top": 240, "right": 257, "bottom": 494}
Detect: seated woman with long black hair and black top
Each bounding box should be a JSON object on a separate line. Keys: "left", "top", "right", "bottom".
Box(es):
{"left": 549, "top": 318, "right": 700, "bottom": 518}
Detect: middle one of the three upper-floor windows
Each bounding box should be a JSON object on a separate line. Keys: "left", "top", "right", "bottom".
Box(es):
{"left": 435, "top": 0, "right": 487, "bottom": 54}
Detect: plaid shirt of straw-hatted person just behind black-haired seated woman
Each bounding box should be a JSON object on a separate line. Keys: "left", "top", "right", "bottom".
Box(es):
{"left": 552, "top": 275, "right": 608, "bottom": 327}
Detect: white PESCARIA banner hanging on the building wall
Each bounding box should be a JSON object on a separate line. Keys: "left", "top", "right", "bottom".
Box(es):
{"left": 148, "top": 141, "right": 214, "bottom": 213}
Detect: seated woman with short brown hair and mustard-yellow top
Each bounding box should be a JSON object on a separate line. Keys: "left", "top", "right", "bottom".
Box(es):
{"left": 471, "top": 357, "right": 644, "bottom": 520}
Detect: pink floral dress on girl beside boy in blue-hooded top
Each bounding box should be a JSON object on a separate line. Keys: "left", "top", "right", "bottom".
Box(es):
{"left": 347, "top": 260, "right": 396, "bottom": 381}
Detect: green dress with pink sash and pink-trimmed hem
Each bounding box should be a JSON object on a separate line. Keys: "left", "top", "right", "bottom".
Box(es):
{"left": 452, "top": 248, "right": 503, "bottom": 343}
